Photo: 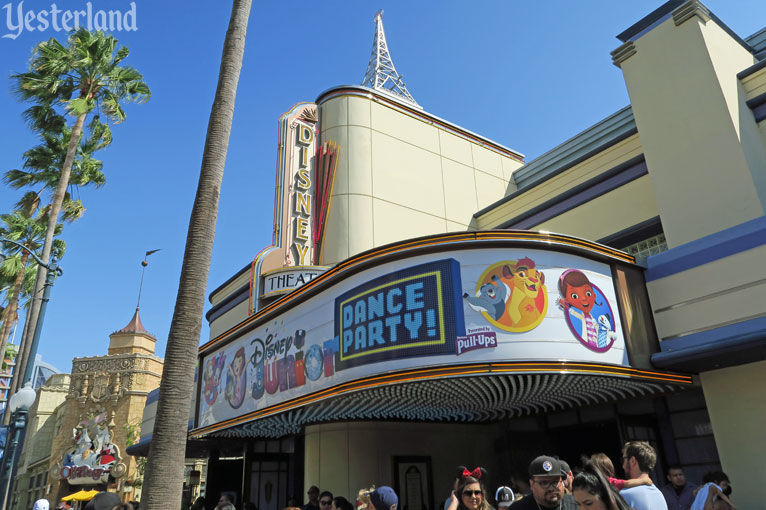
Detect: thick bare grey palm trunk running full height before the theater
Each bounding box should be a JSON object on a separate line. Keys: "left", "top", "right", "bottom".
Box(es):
{"left": 141, "top": 0, "right": 252, "bottom": 510}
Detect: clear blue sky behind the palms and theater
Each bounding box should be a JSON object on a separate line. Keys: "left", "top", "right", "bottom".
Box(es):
{"left": 0, "top": 0, "right": 766, "bottom": 371}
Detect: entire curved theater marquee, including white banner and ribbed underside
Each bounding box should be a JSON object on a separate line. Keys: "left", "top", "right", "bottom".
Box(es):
{"left": 195, "top": 231, "right": 692, "bottom": 438}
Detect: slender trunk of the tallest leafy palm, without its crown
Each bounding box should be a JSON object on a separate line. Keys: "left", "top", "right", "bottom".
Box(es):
{"left": 14, "top": 113, "right": 88, "bottom": 395}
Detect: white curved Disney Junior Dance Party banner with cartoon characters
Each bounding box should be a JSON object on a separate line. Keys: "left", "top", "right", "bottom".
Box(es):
{"left": 197, "top": 248, "right": 628, "bottom": 427}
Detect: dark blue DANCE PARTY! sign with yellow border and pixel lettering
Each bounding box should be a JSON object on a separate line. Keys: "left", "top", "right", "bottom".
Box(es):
{"left": 335, "top": 259, "right": 465, "bottom": 370}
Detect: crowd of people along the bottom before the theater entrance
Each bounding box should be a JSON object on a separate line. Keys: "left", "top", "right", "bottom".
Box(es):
{"left": 200, "top": 441, "right": 735, "bottom": 510}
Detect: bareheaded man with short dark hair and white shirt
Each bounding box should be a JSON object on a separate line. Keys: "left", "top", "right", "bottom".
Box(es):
{"left": 620, "top": 441, "right": 668, "bottom": 510}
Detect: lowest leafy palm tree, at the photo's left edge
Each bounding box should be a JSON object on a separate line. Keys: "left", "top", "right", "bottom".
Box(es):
{"left": 0, "top": 210, "right": 64, "bottom": 396}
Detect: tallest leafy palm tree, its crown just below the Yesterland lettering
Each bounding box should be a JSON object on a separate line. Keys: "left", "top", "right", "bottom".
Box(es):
{"left": 12, "top": 28, "right": 151, "bottom": 386}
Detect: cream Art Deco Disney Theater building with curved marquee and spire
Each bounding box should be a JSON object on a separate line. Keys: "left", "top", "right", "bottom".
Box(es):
{"left": 134, "top": 1, "right": 766, "bottom": 510}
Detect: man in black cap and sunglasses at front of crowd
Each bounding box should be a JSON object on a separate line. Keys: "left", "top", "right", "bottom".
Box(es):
{"left": 509, "top": 455, "right": 577, "bottom": 510}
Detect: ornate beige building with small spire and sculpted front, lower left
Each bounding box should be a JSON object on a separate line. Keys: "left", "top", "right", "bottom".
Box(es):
{"left": 11, "top": 310, "right": 163, "bottom": 509}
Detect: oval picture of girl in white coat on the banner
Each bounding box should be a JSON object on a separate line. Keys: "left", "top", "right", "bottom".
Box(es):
{"left": 559, "top": 269, "right": 617, "bottom": 352}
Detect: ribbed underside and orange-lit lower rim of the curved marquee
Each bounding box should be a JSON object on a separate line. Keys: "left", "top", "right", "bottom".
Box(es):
{"left": 196, "top": 362, "right": 692, "bottom": 438}
